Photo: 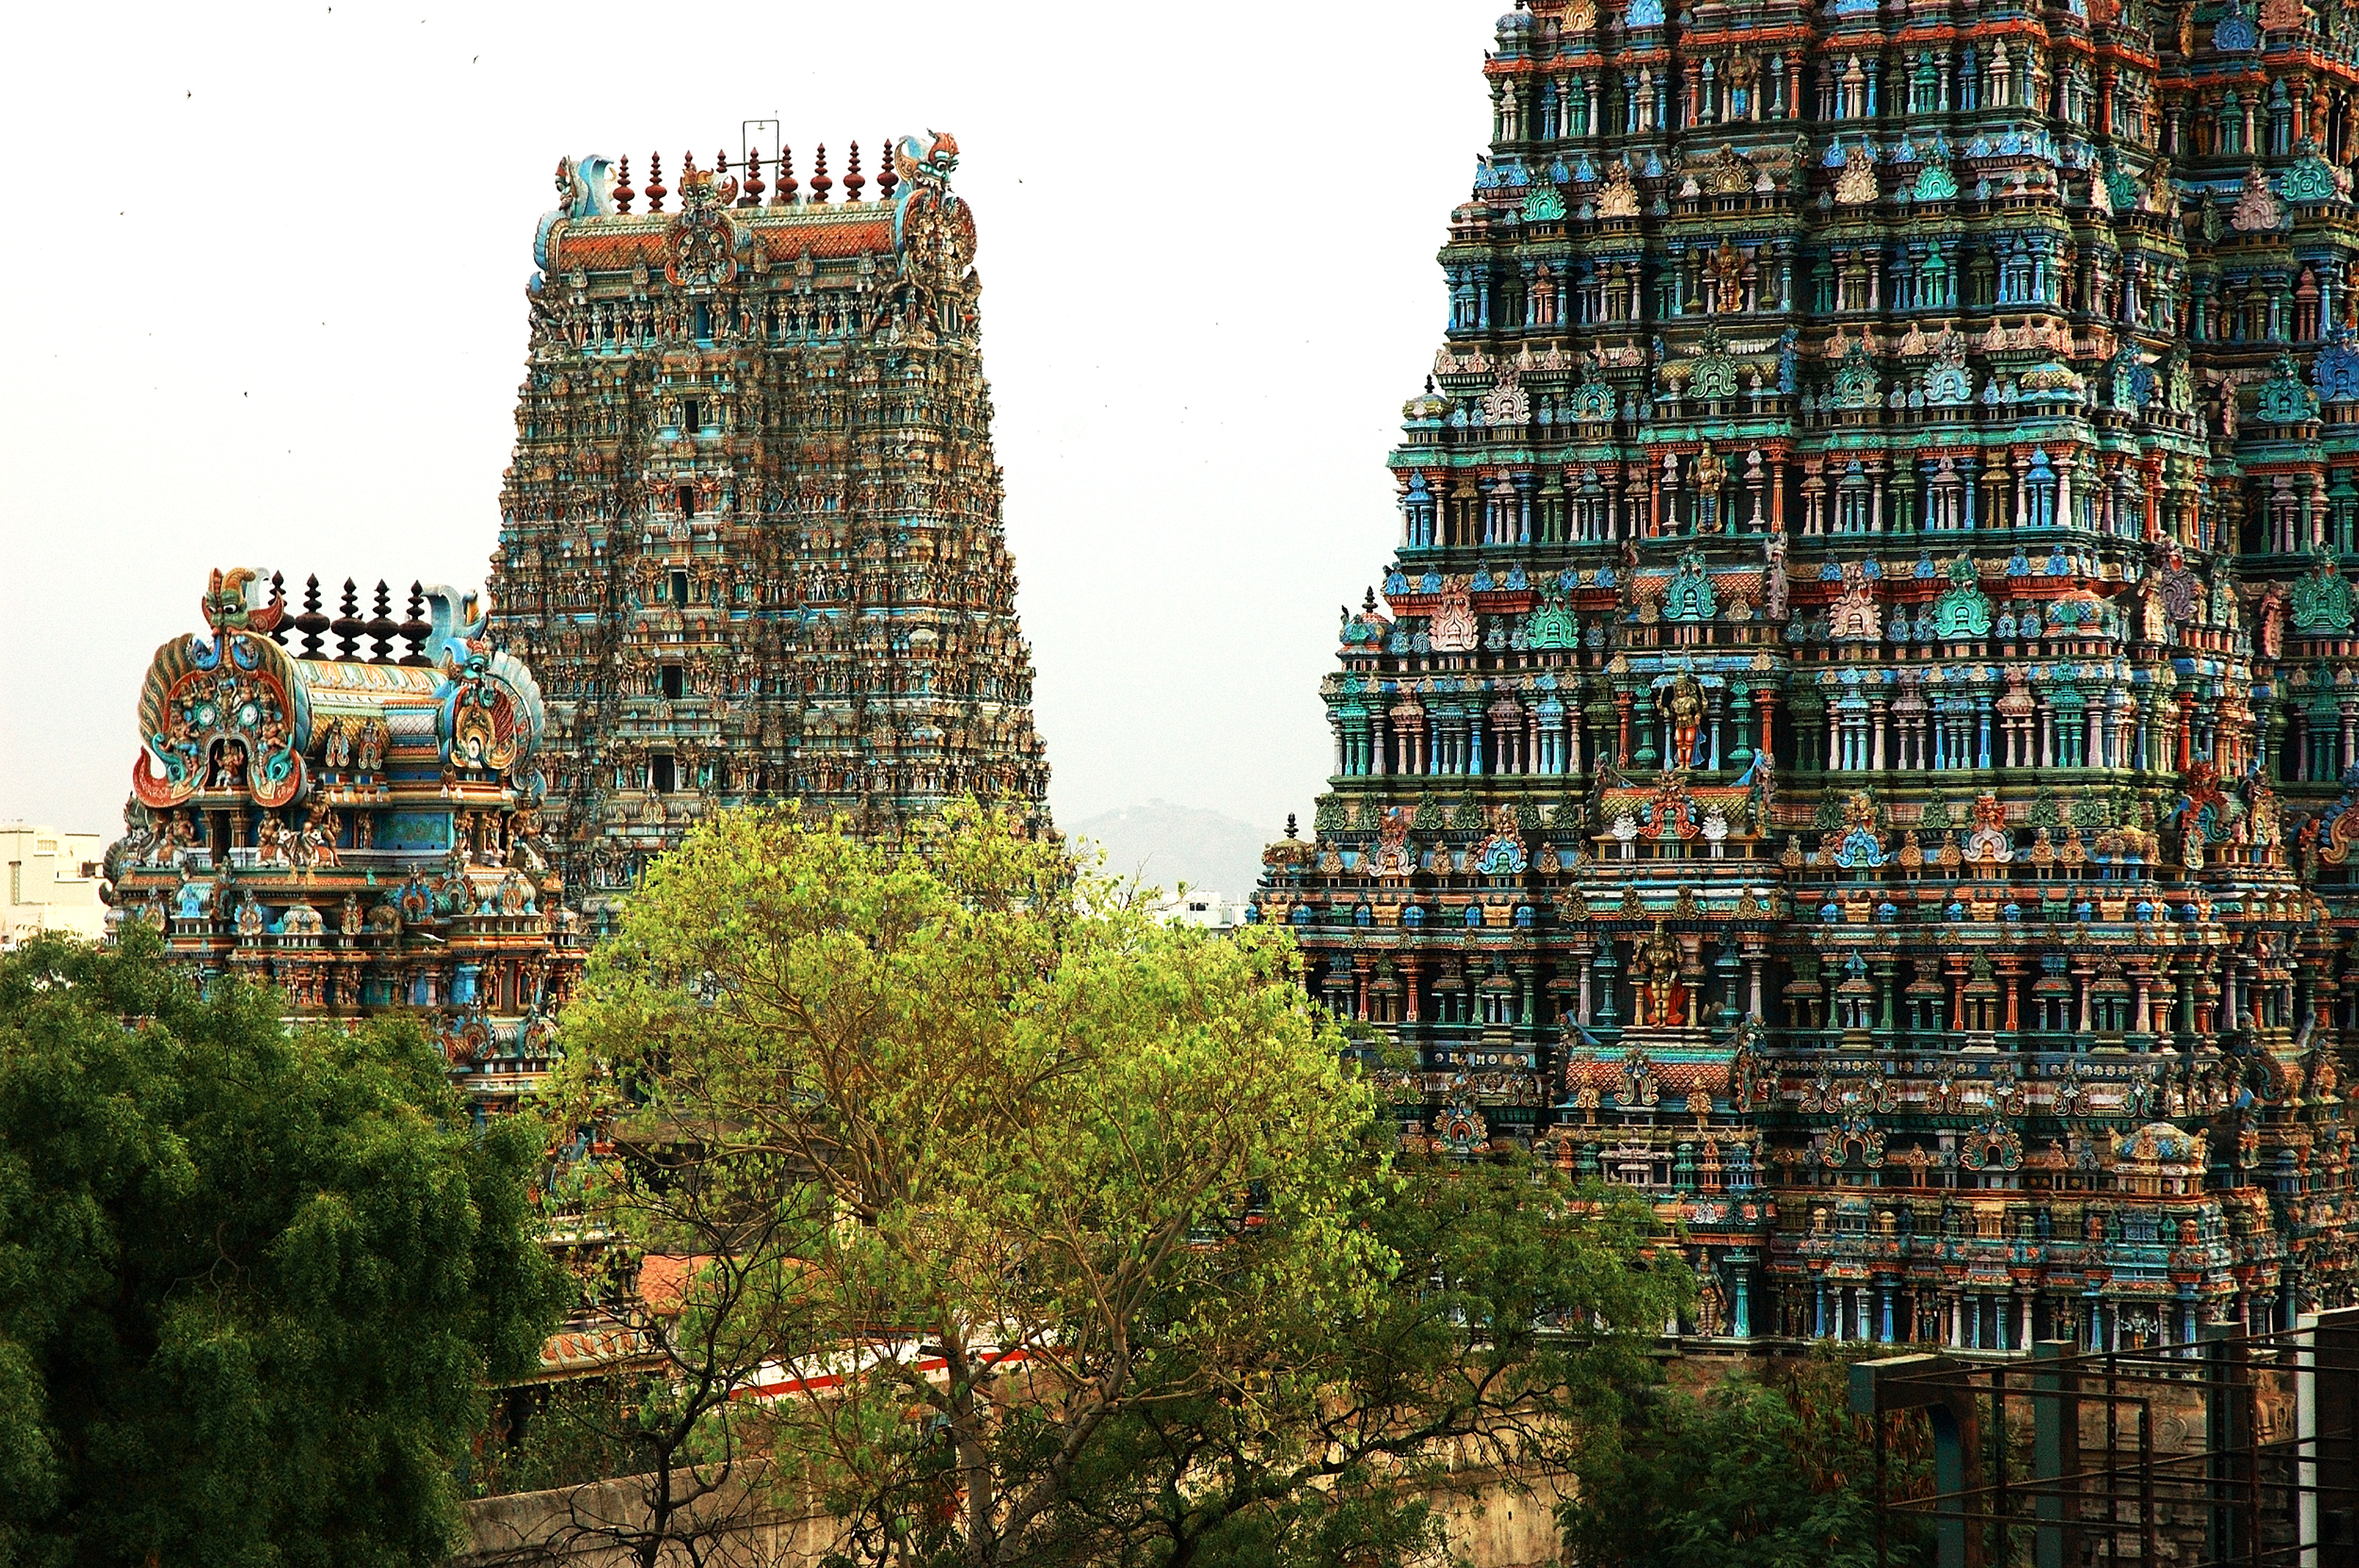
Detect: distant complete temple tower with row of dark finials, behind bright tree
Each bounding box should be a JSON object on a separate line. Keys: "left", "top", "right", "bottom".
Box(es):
{"left": 494, "top": 134, "right": 1047, "bottom": 920}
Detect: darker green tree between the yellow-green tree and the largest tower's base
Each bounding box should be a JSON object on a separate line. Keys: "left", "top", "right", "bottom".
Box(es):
{"left": 1024, "top": 1136, "right": 1692, "bottom": 1568}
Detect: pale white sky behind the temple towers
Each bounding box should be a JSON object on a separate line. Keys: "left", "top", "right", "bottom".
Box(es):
{"left": 0, "top": 0, "right": 1505, "bottom": 837}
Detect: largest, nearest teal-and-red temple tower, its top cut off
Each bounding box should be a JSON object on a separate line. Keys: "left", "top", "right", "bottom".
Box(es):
{"left": 1258, "top": 0, "right": 2359, "bottom": 1351}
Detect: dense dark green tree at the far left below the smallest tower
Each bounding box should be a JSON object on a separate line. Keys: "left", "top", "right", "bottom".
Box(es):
{"left": 0, "top": 925, "right": 564, "bottom": 1568}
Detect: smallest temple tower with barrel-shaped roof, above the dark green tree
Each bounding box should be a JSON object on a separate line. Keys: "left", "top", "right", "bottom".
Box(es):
{"left": 104, "top": 568, "right": 585, "bottom": 1110}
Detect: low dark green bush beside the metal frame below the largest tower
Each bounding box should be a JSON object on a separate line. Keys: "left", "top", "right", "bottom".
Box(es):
{"left": 1557, "top": 1354, "right": 1932, "bottom": 1568}
